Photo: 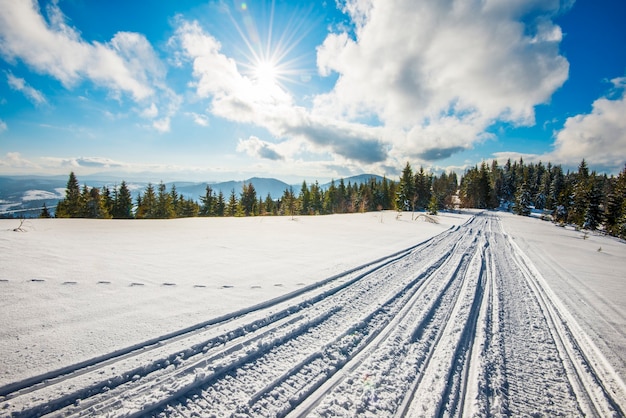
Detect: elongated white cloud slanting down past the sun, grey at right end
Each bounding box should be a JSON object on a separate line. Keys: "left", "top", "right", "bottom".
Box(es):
{"left": 172, "top": 21, "right": 386, "bottom": 163}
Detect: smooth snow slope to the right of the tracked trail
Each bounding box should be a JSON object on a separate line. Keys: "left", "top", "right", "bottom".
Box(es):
{"left": 499, "top": 213, "right": 626, "bottom": 381}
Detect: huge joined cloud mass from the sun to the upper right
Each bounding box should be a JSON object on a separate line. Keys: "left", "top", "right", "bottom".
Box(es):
{"left": 170, "top": 0, "right": 569, "bottom": 167}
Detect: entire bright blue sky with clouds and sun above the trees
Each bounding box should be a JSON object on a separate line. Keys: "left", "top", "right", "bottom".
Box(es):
{"left": 0, "top": 0, "right": 626, "bottom": 182}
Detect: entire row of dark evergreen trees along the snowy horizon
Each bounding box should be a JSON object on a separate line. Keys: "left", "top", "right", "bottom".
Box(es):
{"left": 48, "top": 159, "right": 626, "bottom": 238}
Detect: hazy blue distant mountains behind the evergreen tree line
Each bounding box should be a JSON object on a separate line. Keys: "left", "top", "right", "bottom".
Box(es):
{"left": 0, "top": 174, "right": 383, "bottom": 217}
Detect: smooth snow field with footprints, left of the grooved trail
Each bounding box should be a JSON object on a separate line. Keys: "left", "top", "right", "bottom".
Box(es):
{"left": 0, "top": 212, "right": 460, "bottom": 386}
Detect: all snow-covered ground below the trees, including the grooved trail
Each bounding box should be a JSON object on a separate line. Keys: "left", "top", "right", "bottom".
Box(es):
{"left": 0, "top": 212, "right": 626, "bottom": 416}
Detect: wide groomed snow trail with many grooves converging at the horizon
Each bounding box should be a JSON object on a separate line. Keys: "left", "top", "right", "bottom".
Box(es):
{"left": 0, "top": 213, "right": 626, "bottom": 417}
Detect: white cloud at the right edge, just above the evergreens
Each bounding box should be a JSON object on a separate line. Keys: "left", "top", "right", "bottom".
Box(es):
{"left": 548, "top": 78, "right": 626, "bottom": 171}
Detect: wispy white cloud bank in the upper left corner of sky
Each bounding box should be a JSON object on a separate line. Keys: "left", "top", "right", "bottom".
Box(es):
{"left": 0, "top": 0, "right": 165, "bottom": 101}
